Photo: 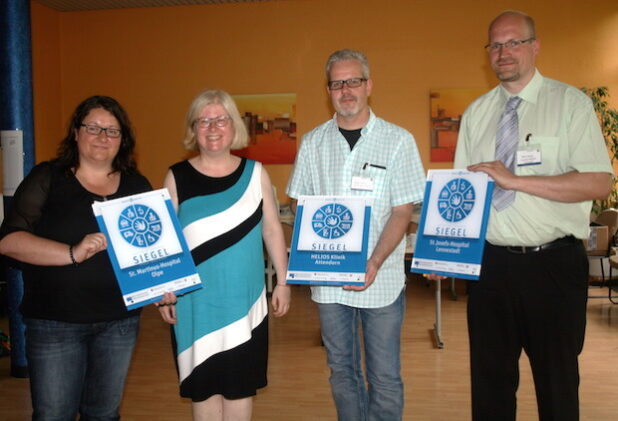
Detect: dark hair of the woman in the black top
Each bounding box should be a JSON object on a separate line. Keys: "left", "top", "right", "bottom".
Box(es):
{"left": 56, "top": 95, "right": 137, "bottom": 173}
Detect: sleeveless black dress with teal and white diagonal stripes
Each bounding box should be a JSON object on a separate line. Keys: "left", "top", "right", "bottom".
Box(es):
{"left": 171, "top": 159, "right": 268, "bottom": 402}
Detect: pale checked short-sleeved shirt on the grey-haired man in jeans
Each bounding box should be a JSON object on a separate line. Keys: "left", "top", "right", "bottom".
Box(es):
{"left": 287, "top": 112, "right": 425, "bottom": 308}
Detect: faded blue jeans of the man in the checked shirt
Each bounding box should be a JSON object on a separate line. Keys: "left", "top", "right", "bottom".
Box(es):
{"left": 318, "top": 291, "right": 405, "bottom": 421}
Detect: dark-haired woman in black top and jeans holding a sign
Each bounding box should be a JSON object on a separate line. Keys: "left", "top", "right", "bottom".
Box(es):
{"left": 0, "top": 96, "right": 151, "bottom": 420}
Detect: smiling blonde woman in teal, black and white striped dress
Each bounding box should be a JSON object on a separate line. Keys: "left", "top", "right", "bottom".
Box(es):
{"left": 159, "top": 90, "right": 290, "bottom": 420}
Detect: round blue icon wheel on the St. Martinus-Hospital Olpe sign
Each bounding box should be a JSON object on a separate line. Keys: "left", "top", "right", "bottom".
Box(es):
{"left": 118, "top": 204, "right": 163, "bottom": 247}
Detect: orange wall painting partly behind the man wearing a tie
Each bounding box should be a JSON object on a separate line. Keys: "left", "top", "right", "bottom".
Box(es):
{"left": 429, "top": 88, "right": 486, "bottom": 162}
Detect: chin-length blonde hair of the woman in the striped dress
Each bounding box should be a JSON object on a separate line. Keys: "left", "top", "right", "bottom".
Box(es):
{"left": 182, "top": 89, "right": 249, "bottom": 151}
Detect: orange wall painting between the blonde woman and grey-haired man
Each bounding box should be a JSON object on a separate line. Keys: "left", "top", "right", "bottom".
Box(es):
{"left": 232, "top": 94, "right": 296, "bottom": 164}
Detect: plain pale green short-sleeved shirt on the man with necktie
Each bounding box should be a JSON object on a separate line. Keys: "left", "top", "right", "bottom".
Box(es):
{"left": 455, "top": 70, "right": 613, "bottom": 246}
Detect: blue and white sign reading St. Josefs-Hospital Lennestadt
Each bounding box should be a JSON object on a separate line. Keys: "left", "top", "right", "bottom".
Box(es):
{"left": 410, "top": 170, "right": 494, "bottom": 279}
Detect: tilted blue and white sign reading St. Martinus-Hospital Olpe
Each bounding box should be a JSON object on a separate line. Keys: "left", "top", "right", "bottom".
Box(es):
{"left": 92, "top": 189, "right": 202, "bottom": 310}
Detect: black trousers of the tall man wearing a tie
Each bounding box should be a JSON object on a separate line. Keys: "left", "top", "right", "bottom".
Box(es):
{"left": 468, "top": 242, "right": 588, "bottom": 421}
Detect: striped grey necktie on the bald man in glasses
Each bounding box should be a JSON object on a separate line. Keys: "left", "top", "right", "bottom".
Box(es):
{"left": 492, "top": 96, "right": 521, "bottom": 211}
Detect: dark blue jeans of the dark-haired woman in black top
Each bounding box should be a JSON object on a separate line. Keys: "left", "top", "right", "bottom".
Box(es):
{"left": 24, "top": 316, "right": 139, "bottom": 421}
